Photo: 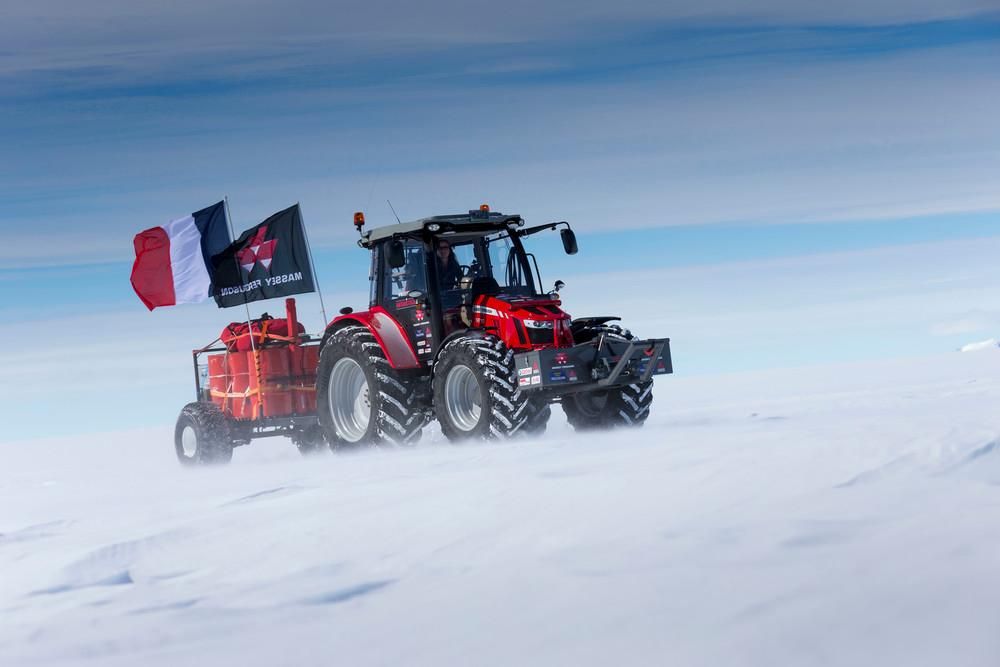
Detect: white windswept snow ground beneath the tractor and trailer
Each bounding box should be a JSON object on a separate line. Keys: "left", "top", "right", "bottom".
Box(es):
{"left": 0, "top": 348, "right": 1000, "bottom": 667}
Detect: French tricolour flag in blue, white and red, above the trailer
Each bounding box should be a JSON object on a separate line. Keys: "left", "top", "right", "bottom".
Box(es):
{"left": 132, "top": 201, "right": 232, "bottom": 310}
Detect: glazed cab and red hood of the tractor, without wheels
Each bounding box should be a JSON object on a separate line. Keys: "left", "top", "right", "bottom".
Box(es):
{"left": 359, "top": 207, "right": 576, "bottom": 366}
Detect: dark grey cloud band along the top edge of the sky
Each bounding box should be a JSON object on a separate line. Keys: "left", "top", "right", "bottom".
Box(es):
{"left": 0, "top": 0, "right": 996, "bottom": 86}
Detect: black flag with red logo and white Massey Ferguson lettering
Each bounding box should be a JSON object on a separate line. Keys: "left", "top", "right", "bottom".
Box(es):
{"left": 212, "top": 204, "right": 316, "bottom": 308}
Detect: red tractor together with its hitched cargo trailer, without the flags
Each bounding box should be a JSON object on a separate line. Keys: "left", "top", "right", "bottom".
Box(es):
{"left": 175, "top": 206, "right": 672, "bottom": 463}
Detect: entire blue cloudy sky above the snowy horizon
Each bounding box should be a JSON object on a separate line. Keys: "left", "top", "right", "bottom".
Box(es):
{"left": 0, "top": 0, "right": 1000, "bottom": 444}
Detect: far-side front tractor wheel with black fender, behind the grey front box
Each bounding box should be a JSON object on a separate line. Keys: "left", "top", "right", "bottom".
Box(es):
{"left": 562, "top": 324, "right": 653, "bottom": 431}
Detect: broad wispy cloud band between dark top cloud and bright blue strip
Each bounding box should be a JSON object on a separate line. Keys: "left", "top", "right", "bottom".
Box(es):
{"left": 9, "top": 42, "right": 1000, "bottom": 266}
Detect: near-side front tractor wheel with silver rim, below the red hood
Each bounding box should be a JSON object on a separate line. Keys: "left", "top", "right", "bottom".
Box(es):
{"left": 432, "top": 336, "right": 532, "bottom": 441}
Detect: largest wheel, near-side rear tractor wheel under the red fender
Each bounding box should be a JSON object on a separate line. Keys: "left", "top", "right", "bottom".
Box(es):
{"left": 316, "top": 326, "right": 427, "bottom": 450}
